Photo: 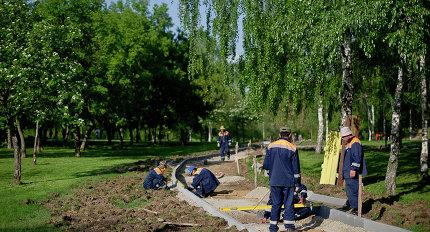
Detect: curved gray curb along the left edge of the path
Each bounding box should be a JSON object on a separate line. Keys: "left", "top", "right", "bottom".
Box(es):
{"left": 172, "top": 148, "right": 257, "bottom": 232}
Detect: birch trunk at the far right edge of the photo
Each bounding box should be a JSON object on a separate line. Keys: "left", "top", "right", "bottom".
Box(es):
{"left": 420, "top": 56, "right": 429, "bottom": 180}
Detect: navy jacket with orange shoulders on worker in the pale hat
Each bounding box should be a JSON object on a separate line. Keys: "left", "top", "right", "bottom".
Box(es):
{"left": 342, "top": 137, "right": 367, "bottom": 179}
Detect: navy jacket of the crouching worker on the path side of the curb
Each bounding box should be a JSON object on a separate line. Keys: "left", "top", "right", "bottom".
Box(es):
{"left": 191, "top": 168, "right": 219, "bottom": 195}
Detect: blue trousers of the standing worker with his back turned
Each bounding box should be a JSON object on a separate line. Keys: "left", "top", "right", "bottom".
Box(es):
{"left": 269, "top": 186, "right": 295, "bottom": 232}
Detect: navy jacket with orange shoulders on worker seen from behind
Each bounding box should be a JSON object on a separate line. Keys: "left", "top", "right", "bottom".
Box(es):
{"left": 263, "top": 138, "right": 300, "bottom": 187}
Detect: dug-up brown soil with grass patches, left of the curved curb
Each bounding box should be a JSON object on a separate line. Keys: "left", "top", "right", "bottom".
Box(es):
{"left": 46, "top": 172, "right": 242, "bottom": 231}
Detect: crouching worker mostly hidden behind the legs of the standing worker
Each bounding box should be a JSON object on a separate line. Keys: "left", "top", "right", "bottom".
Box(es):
{"left": 263, "top": 184, "right": 312, "bottom": 222}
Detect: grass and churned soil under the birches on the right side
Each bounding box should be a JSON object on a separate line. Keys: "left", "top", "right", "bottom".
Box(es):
{"left": 248, "top": 140, "right": 430, "bottom": 231}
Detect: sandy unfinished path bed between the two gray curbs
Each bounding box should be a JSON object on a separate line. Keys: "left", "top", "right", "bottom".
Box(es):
{"left": 185, "top": 153, "right": 364, "bottom": 232}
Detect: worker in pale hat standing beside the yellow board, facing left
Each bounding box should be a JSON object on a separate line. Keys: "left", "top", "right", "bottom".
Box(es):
{"left": 340, "top": 127, "right": 367, "bottom": 215}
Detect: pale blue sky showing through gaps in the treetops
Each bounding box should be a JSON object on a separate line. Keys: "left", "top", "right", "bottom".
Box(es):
{"left": 106, "top": 0, "right": 244, "bottom": 60}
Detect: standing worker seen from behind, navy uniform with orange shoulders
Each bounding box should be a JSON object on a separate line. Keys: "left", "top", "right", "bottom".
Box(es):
{"left": 263, "top": 127, "right": 301, "bottom": 232}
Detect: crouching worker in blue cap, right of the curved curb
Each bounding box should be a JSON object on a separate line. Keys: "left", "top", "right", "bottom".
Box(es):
{"left": 186, "top": 166, "right": 219, "bottom": 198}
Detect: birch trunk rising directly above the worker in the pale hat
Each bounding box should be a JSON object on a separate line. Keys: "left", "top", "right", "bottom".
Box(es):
{"left": 340, "top": 35, "right": 353, "bottom": 125}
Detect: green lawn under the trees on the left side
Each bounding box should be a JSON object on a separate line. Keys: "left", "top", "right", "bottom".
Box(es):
{"left": 0, "top": 143, "right": 216, "bottom": 231}
